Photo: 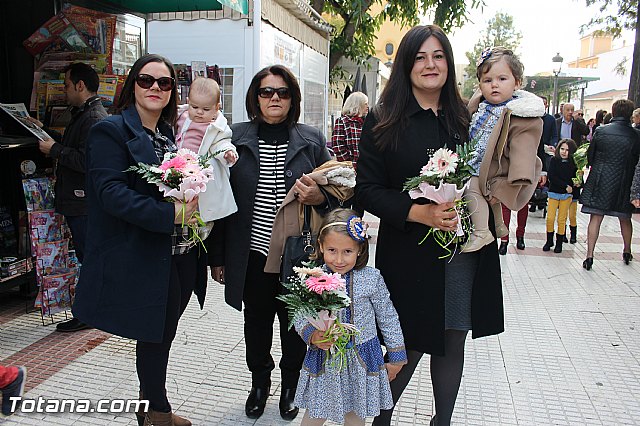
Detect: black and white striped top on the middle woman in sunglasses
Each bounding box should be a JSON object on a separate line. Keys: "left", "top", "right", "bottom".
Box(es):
{"left": 249, "top": 123, "right": 289, "bottom": 256}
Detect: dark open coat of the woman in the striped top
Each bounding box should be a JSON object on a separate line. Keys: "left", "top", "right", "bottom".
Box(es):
{"left": 209, "top": 122, "right": 331, "bottom": 310}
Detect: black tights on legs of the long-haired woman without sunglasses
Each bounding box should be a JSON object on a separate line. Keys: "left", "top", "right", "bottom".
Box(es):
{"left": 373, "top": 330, "right": 468, "bottom": 426}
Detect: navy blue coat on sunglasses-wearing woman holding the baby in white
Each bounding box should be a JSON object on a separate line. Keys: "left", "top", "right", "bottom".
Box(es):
{"left": 73, "top": 106, "right": 207, "bottom": 342}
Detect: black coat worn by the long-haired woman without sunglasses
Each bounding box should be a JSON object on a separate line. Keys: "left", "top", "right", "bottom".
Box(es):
{"left": 356, "top": 101, "right": 504, "bottom": 355}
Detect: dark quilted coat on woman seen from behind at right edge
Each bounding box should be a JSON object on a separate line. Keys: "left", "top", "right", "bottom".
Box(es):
{"left": 580, "top": 117, "right": 640, "bottom": 214}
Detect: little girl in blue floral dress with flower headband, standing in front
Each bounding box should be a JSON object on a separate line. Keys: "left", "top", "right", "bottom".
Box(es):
{"left": 295, "top": 209, "right": 407, "bottom": 426}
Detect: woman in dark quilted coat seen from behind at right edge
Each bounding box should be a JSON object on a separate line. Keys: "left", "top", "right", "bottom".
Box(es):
{"left": 580, "top": 99, "right": 640, "bottom": 271}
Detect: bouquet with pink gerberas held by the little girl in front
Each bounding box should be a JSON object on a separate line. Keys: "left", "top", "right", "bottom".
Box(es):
{"left": 277, "top": 262, "right": 358, "bottom": 370}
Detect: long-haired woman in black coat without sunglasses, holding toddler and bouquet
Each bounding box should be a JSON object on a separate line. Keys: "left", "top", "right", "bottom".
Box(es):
{"left": 356, "top": 25, "right": 504, "bottom": 425}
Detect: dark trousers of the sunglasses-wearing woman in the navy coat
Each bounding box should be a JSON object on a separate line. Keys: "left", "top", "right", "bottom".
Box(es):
{"left": 136, "top": 249, "right": 198, "bottom": 413}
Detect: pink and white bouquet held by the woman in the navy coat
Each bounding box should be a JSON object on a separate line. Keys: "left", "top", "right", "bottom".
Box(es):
{"left": 125, "top": 148, "right": 213, "bottom": 251}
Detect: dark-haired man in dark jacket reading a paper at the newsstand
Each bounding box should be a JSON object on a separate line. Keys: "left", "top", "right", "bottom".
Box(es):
{"left": 36, "top": 62, "right": 107, "bottom": 332}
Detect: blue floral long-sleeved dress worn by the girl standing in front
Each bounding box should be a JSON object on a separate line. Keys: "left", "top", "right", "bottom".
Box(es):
{"left": 295, "top": 266, "right": 407, "bottom": 423}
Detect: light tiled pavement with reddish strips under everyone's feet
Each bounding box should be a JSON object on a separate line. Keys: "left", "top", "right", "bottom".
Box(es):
{"left": 0, "top": 212, "right": 640, "bottom": 425}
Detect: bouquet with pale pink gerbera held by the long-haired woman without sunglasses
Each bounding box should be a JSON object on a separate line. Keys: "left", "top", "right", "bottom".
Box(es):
{"left": 403, "top": 142, "right": 475, "bottom": 259}
